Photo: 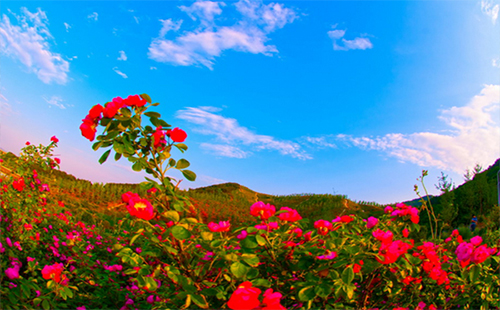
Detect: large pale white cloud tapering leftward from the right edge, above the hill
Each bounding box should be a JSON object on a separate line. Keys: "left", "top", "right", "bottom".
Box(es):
{"left": 337, "top": 85, "right": 500, "bottom": 173}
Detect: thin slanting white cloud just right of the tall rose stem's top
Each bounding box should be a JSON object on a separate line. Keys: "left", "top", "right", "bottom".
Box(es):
{"left": 177, "top": 107, "right": 311, "bottom": 160}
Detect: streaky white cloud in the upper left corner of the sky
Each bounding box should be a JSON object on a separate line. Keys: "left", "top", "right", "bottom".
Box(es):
{"left": 0, "top": 7, "right": 69, "bottom": 84}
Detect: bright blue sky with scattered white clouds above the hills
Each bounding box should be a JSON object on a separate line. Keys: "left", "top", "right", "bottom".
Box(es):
{"left": 0, "top": 0, "right": 500, "bottom": 203}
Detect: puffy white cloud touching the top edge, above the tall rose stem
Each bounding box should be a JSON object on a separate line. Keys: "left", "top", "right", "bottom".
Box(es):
{"left": 149, "top": 0, "right": 297, "bottom": 69}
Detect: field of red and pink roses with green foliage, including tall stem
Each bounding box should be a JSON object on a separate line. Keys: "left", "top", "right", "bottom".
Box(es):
{"left": 0, "top": 95, "right": 500, "bottom": 310}
